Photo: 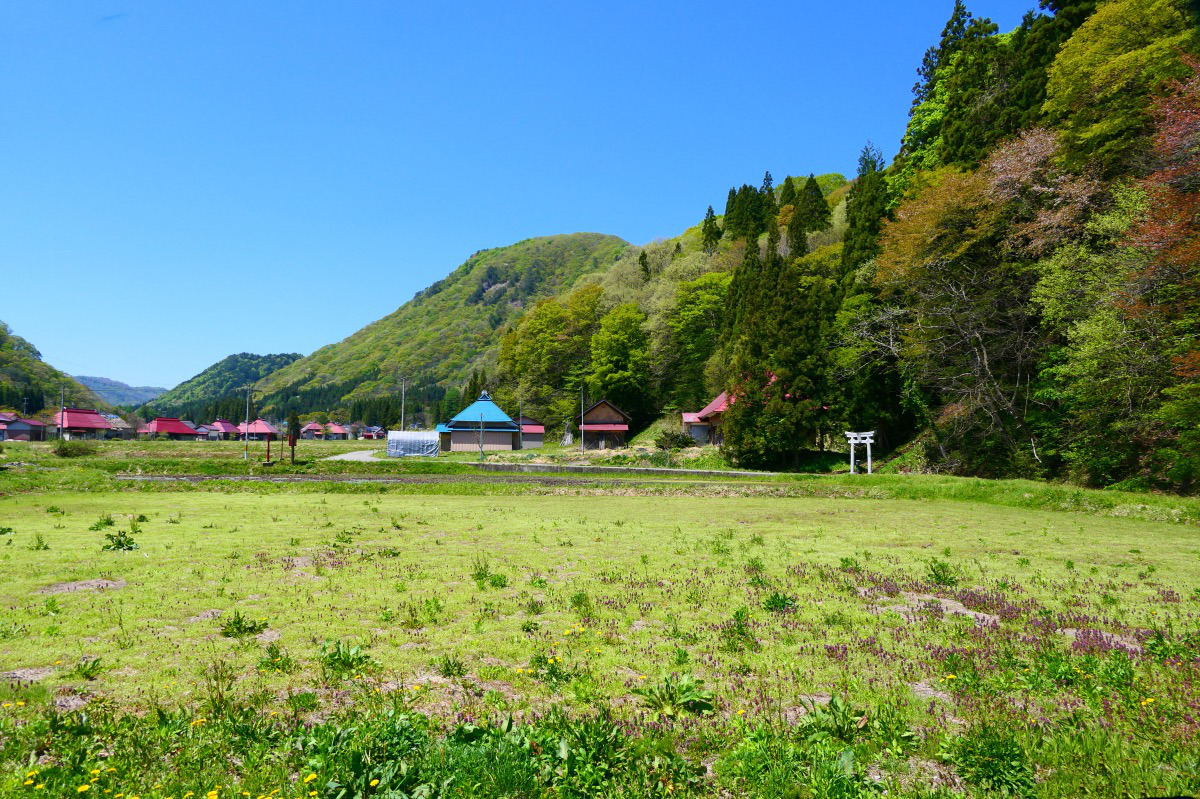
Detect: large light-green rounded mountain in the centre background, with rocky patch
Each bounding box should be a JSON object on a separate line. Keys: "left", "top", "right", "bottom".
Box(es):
{"left": 258, "top": 233, "right": 629, "bottom": 408}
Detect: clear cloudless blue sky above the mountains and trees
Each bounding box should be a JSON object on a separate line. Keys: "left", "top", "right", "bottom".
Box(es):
{"left": 0, "top": 0, "right": 1034, "bottom": 386}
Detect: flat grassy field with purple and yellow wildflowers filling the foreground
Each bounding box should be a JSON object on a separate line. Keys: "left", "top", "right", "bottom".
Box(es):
{"left": 0, "top": 441, "right": 1200, "bottom": 799}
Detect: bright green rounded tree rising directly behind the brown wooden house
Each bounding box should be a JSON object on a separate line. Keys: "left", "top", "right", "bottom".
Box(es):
{"left": 588, "top": 302, "right": 654, "bottom": 425}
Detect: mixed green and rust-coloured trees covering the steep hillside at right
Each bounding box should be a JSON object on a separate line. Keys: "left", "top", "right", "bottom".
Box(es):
{"left": 494, "top": 0, "right": 1200, "bottom": 491}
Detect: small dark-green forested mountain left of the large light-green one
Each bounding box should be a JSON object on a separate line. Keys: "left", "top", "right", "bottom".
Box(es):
{"left": 142, "top": 353, "right": 300, "bottom": 421}
